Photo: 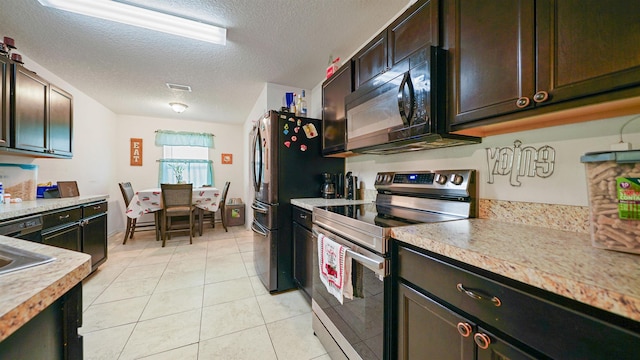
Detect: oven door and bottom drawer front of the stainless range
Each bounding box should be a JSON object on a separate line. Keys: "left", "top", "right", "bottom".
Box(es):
{"left": 311, "top": 225, "right": 388, "bottom": 360}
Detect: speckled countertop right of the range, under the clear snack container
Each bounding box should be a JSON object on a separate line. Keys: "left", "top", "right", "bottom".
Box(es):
{"left": 392, "top": 219, "right": 640, "bottom": 321}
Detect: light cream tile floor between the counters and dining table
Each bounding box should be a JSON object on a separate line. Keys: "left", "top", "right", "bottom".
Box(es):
{"left": 80, "top": 225, "right": 329, "bottom": 360}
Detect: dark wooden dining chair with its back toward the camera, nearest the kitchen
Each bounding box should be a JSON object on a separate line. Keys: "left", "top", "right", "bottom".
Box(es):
{"left": 160, "top": 184, "right": 196, "bottom": 247}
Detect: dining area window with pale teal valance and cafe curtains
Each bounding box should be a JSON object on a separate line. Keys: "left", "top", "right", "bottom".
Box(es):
{"left": 156, "top": 130, "right": 215, "bottom": 187}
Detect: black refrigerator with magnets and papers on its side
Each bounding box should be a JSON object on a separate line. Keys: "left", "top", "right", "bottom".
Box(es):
{"left": 251, "top": 111, "right": 344, "bottom": 292}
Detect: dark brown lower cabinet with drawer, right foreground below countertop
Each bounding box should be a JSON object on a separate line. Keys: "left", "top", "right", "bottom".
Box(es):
{"left": 390, "top": 241, "right": 640, "bottom": 360}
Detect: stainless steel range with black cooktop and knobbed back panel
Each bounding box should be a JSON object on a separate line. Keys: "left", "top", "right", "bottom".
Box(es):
{"left": 312, "top": 170, "right": 478, "bottom": 359}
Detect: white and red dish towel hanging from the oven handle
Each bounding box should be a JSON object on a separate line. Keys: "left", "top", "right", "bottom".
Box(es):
{"left": 318, "top": 234, "right": 353, "bottom": 304}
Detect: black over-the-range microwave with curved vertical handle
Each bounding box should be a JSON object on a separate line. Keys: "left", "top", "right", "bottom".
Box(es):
{"left": 345, "top": 46, "right": 481, "bottom": 154}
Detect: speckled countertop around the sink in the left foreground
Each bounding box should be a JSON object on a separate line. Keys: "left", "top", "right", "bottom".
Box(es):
{"left": 0, "top": 236, "right": 91, "bottom": 341}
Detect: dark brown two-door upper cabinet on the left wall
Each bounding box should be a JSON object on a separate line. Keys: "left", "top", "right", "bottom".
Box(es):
{"left": 10, "top": 64, "right": 73, "bottom": 158}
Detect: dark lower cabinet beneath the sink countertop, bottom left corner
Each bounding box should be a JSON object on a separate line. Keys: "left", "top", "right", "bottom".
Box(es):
{"left": 0, "top": 283, "right": 83, "bottom": 360}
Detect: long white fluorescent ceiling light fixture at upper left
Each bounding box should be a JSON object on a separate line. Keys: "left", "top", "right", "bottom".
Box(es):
{"left": 38, "top": 0, "right": 227, "bottom": 45}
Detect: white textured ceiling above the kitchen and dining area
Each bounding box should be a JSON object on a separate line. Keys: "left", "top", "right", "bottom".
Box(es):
{"left": 0, "top": 0, "right": 413, "bottom": 123}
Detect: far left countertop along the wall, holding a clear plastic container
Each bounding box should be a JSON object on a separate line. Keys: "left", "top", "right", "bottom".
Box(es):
{"left": 0, "top": 195, "right": 109, "bottom": 221}
